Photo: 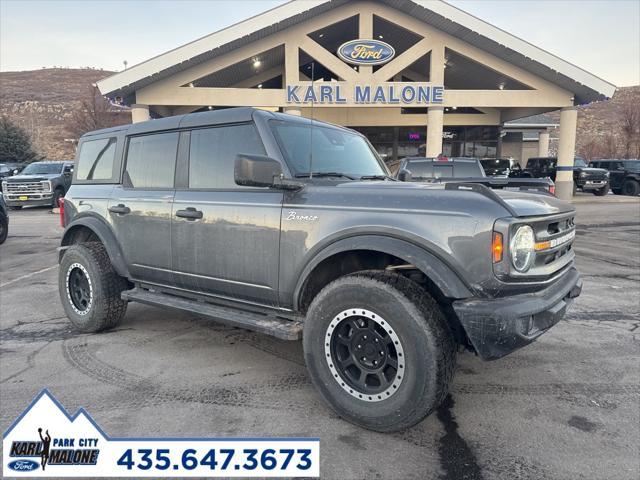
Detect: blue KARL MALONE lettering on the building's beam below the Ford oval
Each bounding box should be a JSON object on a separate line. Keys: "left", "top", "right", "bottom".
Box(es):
{"left": 287, "top": 82, "right": 444, "bottom": 105}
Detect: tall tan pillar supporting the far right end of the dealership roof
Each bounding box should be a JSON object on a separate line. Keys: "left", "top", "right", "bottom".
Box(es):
{"left": 556, "top": 107, "right": 578, "bottom": 200}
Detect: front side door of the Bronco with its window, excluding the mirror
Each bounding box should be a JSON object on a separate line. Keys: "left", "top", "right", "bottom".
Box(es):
{"left": 171, "top": 124, "right": 283, "bottom": 306}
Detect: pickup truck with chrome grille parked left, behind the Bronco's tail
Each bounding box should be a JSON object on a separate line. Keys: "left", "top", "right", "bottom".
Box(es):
{"left": 2, "top": 161, "right": 73, "bottom": 209}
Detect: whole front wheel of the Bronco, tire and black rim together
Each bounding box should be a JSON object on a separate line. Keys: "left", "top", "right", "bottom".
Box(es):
{"left": 303, "top": 271, "right": 456, "bottom": 432}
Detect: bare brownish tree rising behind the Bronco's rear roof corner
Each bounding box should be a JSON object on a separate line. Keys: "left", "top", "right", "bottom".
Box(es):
{"left": 65, "top": 86, "right": 131, "bottom": 139}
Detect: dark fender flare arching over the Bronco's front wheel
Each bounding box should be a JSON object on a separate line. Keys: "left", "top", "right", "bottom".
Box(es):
{"left": 293, "top": 235, "right": 474, "bottom": 310}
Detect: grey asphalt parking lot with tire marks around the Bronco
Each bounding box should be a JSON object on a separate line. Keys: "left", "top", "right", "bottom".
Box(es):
{"left": 0, "top": 194, "right": 640, "bottom": 479}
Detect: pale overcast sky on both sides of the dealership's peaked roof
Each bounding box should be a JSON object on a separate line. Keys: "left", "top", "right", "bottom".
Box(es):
{"left": 0, "top": 0, "right": 640, "bottom": 86}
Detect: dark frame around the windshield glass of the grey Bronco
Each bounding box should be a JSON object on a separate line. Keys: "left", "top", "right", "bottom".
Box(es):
{"left": 267, "top": 119, "right": 393, "bottom": 181}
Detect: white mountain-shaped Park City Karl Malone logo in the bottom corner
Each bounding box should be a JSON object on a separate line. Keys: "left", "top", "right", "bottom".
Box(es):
{"left": 3, "top": 390, "right": 104, "bottom": 474}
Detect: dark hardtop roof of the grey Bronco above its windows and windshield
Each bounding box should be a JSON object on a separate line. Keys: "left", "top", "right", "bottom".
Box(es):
{"left": 82, "top": 107, "right": 353, "bottom": 138}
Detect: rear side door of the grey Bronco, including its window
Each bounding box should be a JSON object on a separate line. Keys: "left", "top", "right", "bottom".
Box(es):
{"left": 108, "top": 132, "right": 179, "bottom": 284}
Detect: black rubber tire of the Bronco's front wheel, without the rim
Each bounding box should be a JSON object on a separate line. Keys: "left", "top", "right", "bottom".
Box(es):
{"left": 303, "top": 271, "right": 456, "bottom": 432}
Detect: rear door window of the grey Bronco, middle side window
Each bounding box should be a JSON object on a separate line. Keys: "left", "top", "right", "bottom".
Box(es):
{"left": 124, "top": 132, "right": 179, "bottom": 189}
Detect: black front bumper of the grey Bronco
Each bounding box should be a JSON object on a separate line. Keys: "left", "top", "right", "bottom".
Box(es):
{"left": 453, "top": 268, "right": 582, "bottom": 360}
